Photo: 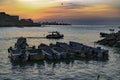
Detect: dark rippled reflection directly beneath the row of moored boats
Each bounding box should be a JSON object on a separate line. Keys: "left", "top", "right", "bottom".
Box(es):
{"left": 11, "top": 59, "right": 108, "bottom": 69}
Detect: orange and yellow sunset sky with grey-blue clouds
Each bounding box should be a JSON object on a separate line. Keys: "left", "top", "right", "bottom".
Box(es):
{"left": 0, "top": 0, "right": 120, "bottom": 24}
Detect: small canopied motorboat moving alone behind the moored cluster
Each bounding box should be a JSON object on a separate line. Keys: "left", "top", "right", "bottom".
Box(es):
{"left": 46, "top": 31, "right": 64, "bottom": 39}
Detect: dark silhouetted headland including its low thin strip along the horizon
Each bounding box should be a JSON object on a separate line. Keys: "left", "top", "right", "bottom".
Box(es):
{"left": 0, "top": 12, "right": 70, "bottom": 27}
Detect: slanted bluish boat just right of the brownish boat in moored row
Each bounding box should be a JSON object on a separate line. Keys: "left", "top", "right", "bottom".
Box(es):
{"left": 38, "top": 43, "right": 54, "bottom": 60}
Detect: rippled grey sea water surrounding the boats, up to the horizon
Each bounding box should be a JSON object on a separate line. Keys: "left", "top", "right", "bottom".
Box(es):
{"left": 0, "top": 25, "right": 120, "bottom": 80}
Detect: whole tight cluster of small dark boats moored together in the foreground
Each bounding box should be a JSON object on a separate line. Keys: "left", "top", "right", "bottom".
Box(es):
{"left": 8, "top": 37, "right": 109, "bottom": 62}
